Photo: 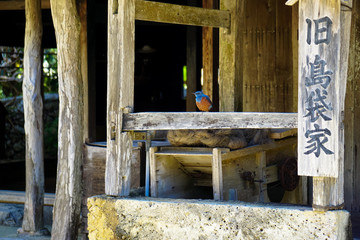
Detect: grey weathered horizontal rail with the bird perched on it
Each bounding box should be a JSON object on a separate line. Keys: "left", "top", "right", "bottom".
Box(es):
{"left": 123, "top": 112, "right": 297, "bottom": 131}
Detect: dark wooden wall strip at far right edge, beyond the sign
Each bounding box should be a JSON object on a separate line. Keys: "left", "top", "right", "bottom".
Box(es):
{"left": 344, "top": 1, "right": 360, "bottom": 212}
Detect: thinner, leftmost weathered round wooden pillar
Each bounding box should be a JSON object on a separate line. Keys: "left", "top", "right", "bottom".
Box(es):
{"left": 18, "top": 0, "right": 48, "bottom": 235}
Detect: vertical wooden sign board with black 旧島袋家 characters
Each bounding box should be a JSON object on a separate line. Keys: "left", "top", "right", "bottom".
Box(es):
{"left": 298, "top": 0, "right": 345, "bottom": 177}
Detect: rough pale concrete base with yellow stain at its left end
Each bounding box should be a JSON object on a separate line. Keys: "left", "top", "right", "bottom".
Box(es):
{"left": 88, "top": 196, "right": 352, "bottom": 240}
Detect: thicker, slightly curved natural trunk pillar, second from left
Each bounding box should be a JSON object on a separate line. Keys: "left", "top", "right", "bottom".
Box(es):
{"left": 50, "top": 0, "right": 84, "bottom": 240}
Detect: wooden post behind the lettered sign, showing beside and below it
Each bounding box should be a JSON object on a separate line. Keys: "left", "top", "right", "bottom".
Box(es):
{"left": 313, "top": 3, "right": 351, "bottom": 210}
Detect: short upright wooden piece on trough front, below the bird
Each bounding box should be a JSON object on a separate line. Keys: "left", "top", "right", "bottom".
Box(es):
{"left": 211, "top": 148, "right": 224, "bottom": 201}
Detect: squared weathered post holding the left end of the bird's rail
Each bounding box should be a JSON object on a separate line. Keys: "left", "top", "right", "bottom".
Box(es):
{"left": 105, "top": 0, "right": 135, "bottom": 196}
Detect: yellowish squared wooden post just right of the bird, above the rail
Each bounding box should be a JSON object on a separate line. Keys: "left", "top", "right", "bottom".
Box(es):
{"left": 219, "top": 0, "right": 245, "bottom": 112}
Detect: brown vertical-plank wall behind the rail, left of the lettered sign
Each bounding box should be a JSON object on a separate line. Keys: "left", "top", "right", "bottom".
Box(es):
{"left": 240, "top": 0, "right": 297, "bottom": 112}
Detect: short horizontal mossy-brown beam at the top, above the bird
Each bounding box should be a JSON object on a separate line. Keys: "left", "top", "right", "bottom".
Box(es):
{"left": 135, "top": 0, "right": 230, "bottom": 28}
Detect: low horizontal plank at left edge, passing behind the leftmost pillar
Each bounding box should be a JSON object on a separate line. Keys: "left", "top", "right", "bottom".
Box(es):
{"left": 0, "top": 190, "right": 55, "bottom": 206}
